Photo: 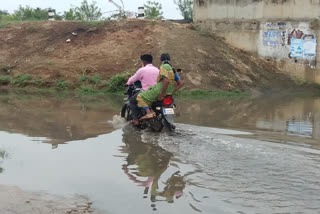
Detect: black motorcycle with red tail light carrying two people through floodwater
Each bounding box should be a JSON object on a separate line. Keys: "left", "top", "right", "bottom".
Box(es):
{"left": 121, "top": 81, "right": 176, "bottom": 132}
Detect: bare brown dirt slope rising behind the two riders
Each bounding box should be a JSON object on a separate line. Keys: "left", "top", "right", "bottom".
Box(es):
{"left": 0, "top": 20, "right": 294, "bottom": 90}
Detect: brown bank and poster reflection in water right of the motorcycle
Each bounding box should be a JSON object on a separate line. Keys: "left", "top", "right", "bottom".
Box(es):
{"left": 178, "top": 95, "right": 320, "bottom": 143}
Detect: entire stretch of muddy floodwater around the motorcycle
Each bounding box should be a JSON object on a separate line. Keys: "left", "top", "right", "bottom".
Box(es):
{"left": 0, "top": 91, "right": 320, "bottom": 214}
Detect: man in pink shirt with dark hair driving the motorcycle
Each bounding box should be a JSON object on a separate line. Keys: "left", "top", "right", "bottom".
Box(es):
{"left": 127, "top": 54, "right": 159, "bottom": 91}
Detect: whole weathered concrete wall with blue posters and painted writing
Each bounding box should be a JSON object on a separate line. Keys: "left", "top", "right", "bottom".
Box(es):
{"left": 194, "top": 0, "right": 320, "bottom": 83}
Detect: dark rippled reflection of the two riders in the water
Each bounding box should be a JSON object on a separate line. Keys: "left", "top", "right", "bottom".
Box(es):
{"left": 121, "top": 127, "right": 185, "bottom": 210}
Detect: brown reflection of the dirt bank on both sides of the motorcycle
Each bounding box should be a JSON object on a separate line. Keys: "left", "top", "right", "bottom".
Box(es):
{"left": 0, "top": 91, "right": 320, "bottom": 146}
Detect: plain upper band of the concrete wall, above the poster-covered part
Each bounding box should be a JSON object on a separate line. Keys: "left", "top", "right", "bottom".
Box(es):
{"left": 194, "top": 0, "right": 319, "bottom": 21}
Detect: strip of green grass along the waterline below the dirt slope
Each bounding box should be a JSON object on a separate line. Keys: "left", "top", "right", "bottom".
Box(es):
{"left": 0, "top": 72, "right": 246, "bottom": 99}
